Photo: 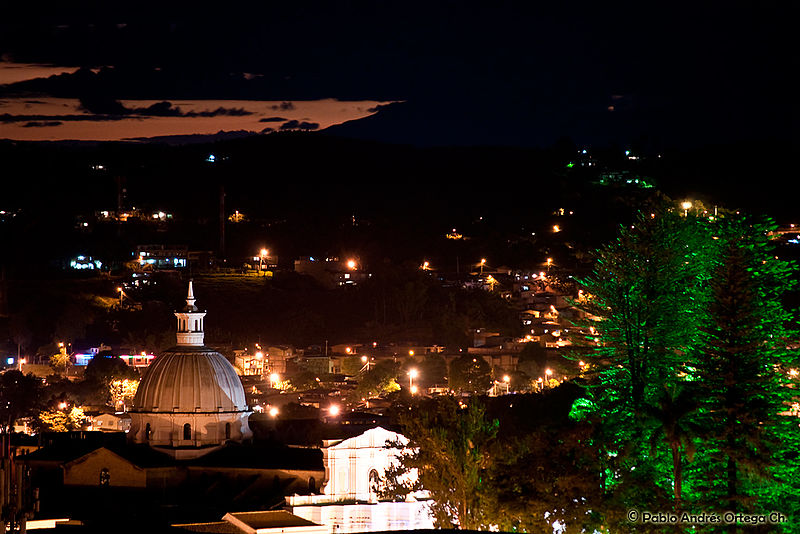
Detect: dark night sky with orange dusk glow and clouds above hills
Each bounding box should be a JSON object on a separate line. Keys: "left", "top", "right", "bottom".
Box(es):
{"left": 0, "top": 1, "right": 797, "bottom": 151}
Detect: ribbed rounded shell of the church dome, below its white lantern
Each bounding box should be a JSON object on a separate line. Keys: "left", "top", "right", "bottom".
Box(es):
{"left": 131, "top": 346, "right": 247, "bottom": 413}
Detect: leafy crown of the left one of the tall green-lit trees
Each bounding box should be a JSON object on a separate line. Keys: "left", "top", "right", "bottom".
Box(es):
{"left": 582, "top": 204, "right": 715, "bottom": 416}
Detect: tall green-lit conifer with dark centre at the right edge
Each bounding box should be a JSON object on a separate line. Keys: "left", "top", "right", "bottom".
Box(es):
{"left": 695, "top": 233, "right": 798, "bottom": 512}
